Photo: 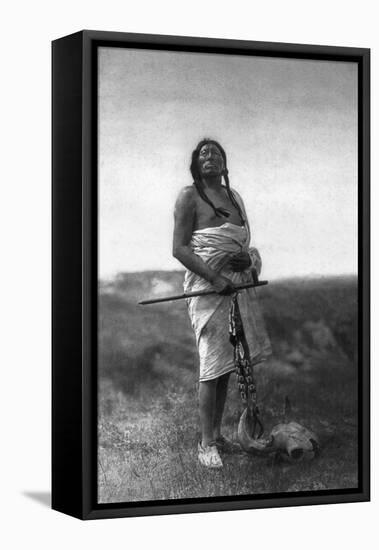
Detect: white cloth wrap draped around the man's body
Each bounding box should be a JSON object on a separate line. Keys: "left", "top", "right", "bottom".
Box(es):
{"left": 184, "top": 222, "right": 271, "bottom": 382}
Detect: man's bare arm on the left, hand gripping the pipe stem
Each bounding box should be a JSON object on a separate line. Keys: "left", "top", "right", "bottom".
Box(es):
{"left": 172, "top": 187, "right": 234, "bottom": 294}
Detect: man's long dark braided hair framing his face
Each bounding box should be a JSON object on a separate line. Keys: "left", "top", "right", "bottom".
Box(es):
{"left": 190, "top": 138, "right": 244, "bottom": 220}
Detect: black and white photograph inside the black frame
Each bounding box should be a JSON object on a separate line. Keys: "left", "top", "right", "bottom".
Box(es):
{"left": 97, "top": 46, "right": 359, "bottom": 504}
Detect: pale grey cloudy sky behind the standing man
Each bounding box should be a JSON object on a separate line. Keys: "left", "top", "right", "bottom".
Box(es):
{"left": 98, "top": 47, "right": 358, "bottom": 279}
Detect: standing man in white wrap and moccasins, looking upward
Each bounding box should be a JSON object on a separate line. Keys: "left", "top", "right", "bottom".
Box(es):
{"left": 173, "top": 139, "right": 271, "bottom": 468}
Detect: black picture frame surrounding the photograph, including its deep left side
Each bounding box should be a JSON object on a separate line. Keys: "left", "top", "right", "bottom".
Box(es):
{"left": 52, "top": 30, "right": 370, "bottom": 519}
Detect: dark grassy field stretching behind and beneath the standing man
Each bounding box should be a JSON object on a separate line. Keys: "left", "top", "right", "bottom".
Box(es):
{"left": 98, "top": 272, "right": 357, "bottom": 503}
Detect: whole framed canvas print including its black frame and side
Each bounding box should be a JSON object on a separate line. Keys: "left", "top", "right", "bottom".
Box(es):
{"left": 52, "top": 31, "right": 370, "bottom": 519}
